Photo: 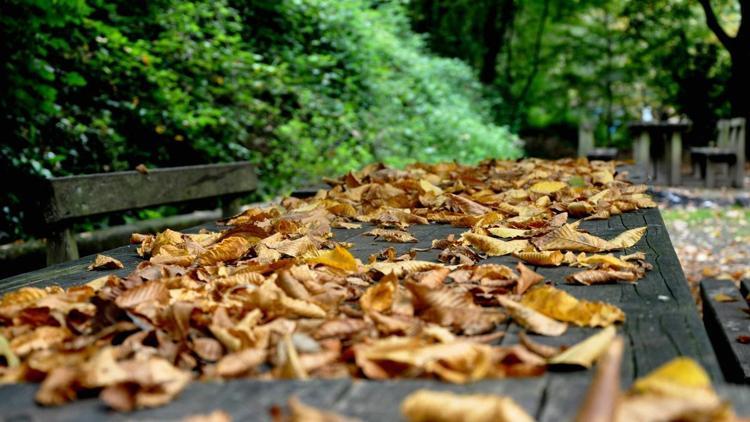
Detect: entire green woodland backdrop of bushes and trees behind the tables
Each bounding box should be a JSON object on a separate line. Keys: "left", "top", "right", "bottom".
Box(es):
{"left": 0, "top": 0, "right": 750, "bottom": 243}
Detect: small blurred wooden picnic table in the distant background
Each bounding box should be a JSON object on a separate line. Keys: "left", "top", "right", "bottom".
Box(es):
{"left": 628, "top": 122, "right": 690, "bottom": 186}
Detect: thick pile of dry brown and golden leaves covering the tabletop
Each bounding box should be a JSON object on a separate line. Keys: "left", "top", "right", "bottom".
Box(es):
{"left": 0, "top": 160, "right": 654, "bottom": 410}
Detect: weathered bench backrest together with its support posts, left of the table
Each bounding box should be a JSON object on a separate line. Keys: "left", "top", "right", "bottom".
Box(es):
{"left": 40, "top": 162, "right": 257, "bottom": 265}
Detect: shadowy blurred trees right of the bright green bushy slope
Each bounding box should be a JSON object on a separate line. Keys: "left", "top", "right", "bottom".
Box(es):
{"left": 409, "top": 0, "right": 739, "bottom": 153}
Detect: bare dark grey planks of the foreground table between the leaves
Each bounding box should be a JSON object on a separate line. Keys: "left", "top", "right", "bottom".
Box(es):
{"left": 0, "top": 167, "right": 750, "bottom": 421}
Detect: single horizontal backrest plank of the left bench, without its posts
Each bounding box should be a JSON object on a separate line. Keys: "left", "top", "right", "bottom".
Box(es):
{"left": 44, "top": 162, "right": 258, "bottom": 223}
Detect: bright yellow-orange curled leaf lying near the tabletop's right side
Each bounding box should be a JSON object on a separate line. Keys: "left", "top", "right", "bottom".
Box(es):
{"left": 521, "top": 286, "right": 625, "bottom": 327}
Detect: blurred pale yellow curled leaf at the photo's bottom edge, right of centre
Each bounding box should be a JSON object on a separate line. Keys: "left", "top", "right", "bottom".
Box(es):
{"left": 401, "top": 390, "right": 534, "bottom": 422}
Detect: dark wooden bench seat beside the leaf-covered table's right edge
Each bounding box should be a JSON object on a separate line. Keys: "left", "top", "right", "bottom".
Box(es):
{"left": 701, "top": 279, "right": 750, "bottom": 384}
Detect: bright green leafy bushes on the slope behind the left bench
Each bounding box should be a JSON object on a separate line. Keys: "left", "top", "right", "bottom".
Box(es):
{"left": 0, "top": 0, "right": 520, "bottom": 241}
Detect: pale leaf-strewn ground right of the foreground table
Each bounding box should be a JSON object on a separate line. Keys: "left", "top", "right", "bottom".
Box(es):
{"left": 655, "top": 188, "right": 750, "bottom": 298}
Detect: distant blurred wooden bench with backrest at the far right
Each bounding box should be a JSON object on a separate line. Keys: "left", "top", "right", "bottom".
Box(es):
{"left": 690, "top": 118, "right": 746, "bottom": 188}
